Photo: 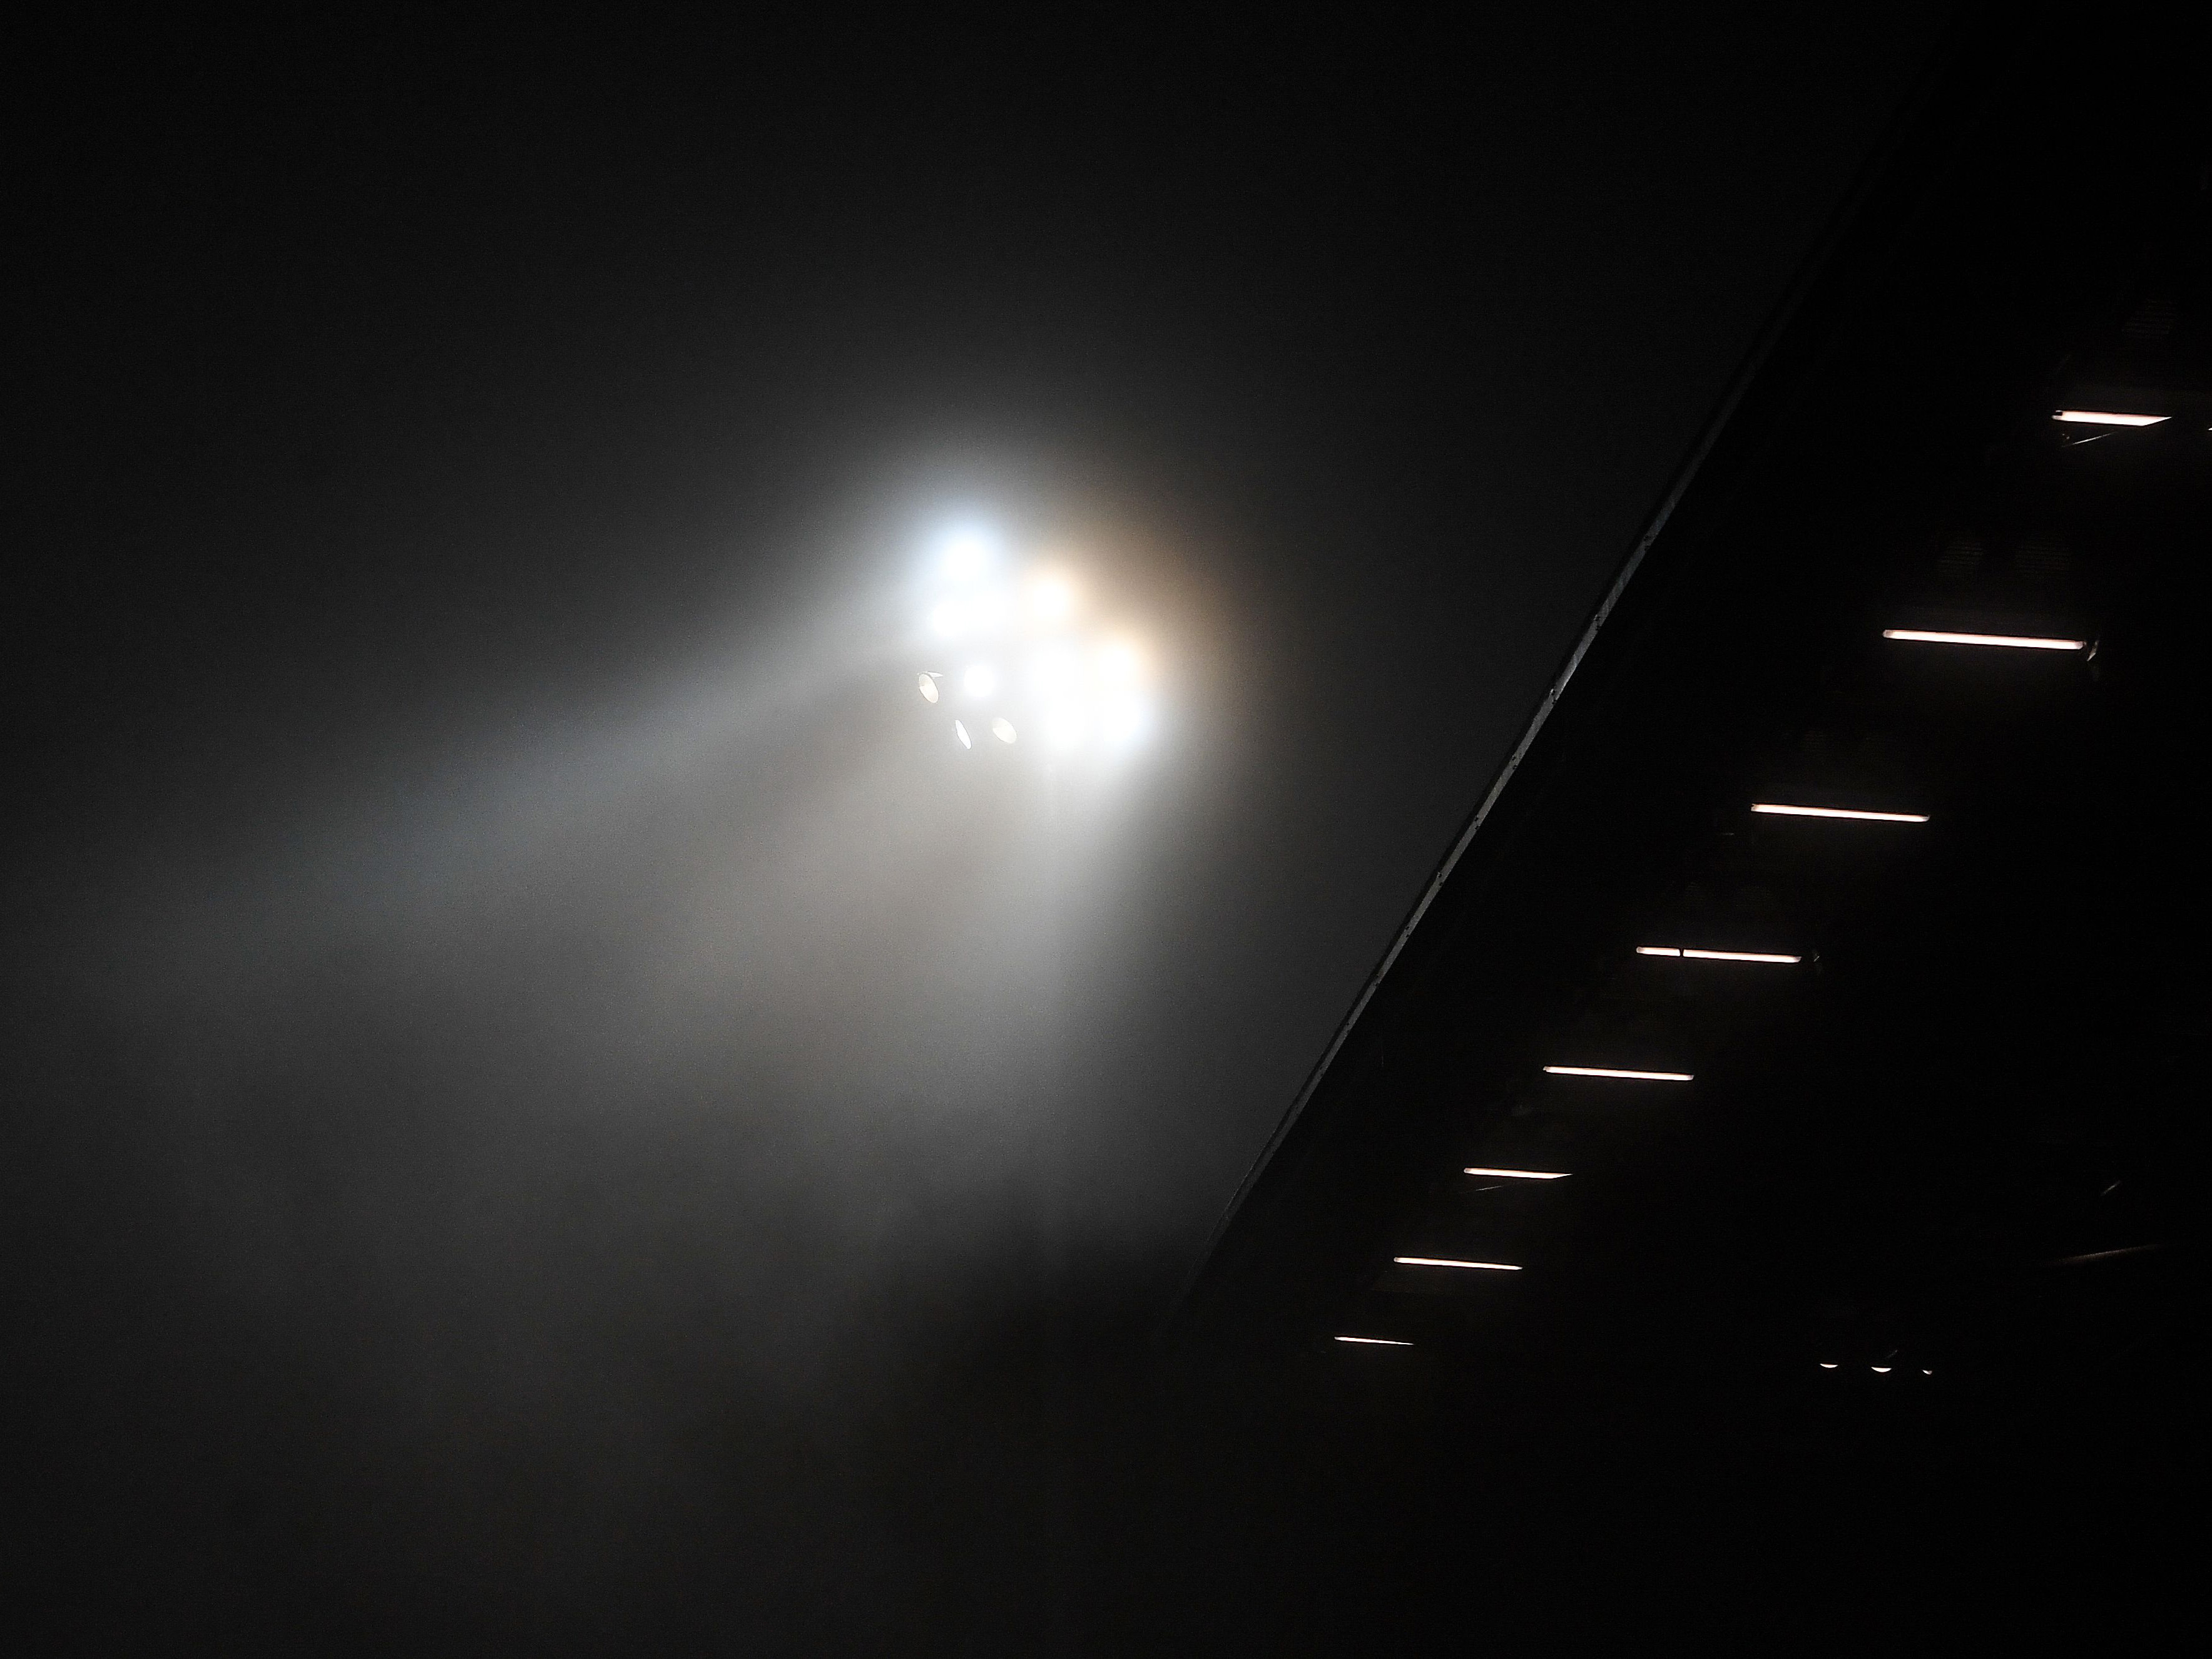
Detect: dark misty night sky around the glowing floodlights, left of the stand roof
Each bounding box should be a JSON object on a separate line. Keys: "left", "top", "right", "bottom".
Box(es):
{"left": 13, "top": 7, "right": 1934, "bottom": 1646}
